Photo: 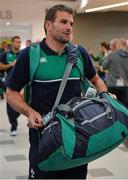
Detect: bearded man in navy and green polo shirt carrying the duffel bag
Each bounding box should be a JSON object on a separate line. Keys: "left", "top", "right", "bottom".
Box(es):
{"left": 6, "top": 4, "right": 107, "bottom": 179}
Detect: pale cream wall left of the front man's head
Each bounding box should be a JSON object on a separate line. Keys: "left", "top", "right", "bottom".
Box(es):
{"left": 0, "top": 2, "right": 45, "bottom": 41}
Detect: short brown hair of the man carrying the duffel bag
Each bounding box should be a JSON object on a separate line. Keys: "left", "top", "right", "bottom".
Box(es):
{"left": 44, "top": 4, "right": 74, "bottom": 33}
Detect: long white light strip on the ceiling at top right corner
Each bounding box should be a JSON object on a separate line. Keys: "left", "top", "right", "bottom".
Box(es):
{"left": 85, "top": 2, "right": 128, "bottom": 12}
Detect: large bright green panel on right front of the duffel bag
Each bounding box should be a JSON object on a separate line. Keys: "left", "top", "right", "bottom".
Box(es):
{"left": 86, "top": 120, "right": 128, "bottom": 156}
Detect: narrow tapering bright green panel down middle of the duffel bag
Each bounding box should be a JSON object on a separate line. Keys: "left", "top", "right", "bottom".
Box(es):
{"left": 56, "top": 113, "right": 76, "bottom": 158}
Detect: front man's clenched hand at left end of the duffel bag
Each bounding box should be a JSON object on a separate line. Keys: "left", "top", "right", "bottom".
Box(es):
{"left": 27, "top": 111, "right": 43, "bottom": 129}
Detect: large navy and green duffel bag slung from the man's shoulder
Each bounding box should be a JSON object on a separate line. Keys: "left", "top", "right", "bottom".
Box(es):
{"left": 39, "top": 92, "right": 128, "bottom": 171}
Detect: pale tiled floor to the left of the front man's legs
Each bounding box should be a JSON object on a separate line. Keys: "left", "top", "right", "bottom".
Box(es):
{"left": 0, "top": 100, "right": 29, "bottom": 179}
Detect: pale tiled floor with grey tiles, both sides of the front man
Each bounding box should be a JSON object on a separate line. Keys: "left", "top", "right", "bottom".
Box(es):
{"left": 0, "top": 100, "right": 128, "bottom": 180}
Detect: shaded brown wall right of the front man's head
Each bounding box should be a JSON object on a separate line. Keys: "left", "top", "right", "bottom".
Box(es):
{"left": 73, "top": 12, "right": 128, "bottom": 53}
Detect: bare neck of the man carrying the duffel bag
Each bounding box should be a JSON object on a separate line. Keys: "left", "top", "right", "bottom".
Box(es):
{"left": 45, "top": 38, "right": 66, "bottom": 55}
